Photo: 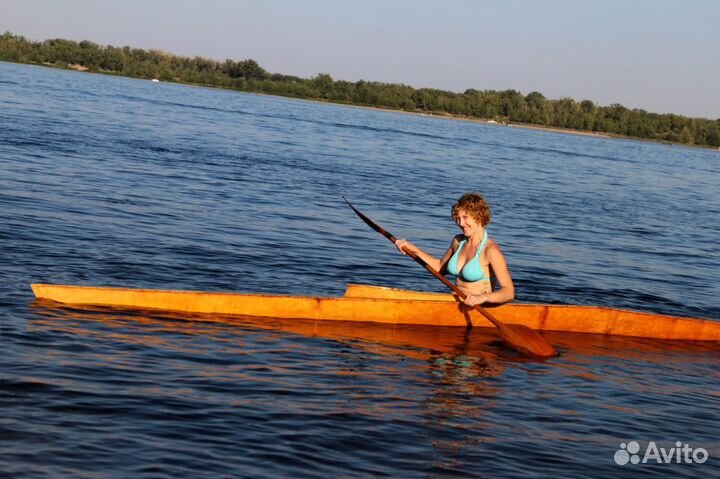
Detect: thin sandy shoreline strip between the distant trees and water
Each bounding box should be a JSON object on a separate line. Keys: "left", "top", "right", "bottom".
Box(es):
{"left": 10, "top": 62, "right": 720, "bottom": 151}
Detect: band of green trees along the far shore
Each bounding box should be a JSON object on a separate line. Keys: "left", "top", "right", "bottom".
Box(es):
{"left": 0, "top": 32, "right": 720, "bottom": 147}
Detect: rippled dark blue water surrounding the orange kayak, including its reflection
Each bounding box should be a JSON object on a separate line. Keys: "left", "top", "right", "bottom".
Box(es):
{"left": 0, "top": 63, "right": 720, "bottom": 478}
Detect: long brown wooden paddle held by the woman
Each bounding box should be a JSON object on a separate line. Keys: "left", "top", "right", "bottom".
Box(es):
{"left": 343, "top": 196, "right": 558, "bottom": 358}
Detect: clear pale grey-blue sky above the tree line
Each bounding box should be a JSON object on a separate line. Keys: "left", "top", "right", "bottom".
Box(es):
{"left": 0, "top": 0, "right": 720, "bottom": 119}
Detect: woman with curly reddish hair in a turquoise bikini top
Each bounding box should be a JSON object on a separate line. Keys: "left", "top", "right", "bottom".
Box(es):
{"left": 395, "top": 192, "right": 515, "bottom": 306}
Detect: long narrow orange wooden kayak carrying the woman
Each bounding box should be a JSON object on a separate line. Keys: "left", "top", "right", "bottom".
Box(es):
{"left": 31, "top": 284, "right": 720, "bottom": 341}
